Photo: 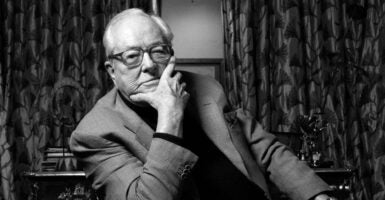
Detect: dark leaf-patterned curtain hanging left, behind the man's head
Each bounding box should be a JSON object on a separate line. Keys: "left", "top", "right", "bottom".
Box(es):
{"left": 0, "top": 0, "right": 151, "bottom": 200}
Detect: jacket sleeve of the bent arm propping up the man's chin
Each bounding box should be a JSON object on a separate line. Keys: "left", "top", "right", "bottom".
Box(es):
{"left": 70, "top": 128, "right": 198, "bottom": 200}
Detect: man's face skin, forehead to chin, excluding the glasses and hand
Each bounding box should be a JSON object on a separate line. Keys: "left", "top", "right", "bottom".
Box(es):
{"left": 105, "top": 16, "right": 167, "bottom": 103}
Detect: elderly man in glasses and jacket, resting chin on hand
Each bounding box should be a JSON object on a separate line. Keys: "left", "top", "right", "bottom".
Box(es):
{"left": 70, "top": 9, "right": 329, "bottom": 200}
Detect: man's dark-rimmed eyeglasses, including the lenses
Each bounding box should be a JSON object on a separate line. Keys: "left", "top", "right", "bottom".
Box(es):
{"left": 108, "top": 44, "right": 174, "bottom": 68}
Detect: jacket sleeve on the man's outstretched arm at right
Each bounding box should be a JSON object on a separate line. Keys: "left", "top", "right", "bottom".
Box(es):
{"left": 230, "top": 109, "right": 330, "bottom": 200}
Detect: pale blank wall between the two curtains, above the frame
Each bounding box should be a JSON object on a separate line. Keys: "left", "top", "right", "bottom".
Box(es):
{"left": 161, "top": 0, "right": 223, "bottom": 58}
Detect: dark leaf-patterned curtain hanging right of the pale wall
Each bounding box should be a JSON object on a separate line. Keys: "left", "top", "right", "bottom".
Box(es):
{"left": 222, "top": 0, "right": 385, "bottom": 200}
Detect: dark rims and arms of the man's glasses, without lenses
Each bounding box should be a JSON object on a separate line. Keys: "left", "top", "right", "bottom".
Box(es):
{"left": 107, "top": 43, "right": 174, "bottom": 69}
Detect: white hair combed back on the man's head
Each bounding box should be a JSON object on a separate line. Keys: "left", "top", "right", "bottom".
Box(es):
{"left": 103, "top": 8, "right": 174, "bottom": 56}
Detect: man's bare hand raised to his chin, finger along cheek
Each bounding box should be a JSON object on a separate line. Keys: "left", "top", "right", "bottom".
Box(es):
{"left": 130, "top": 56, "right": 190, "bottom": 137}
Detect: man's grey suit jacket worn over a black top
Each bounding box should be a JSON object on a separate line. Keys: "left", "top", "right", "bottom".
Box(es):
{"left": 70, "top": 73, "right": 329, "bottom": 200}
